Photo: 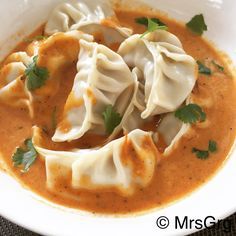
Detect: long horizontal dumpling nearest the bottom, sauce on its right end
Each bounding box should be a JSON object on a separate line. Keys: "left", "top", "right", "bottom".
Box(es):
{"left": 33, "top": 128, "right": 160, "bottom": 195}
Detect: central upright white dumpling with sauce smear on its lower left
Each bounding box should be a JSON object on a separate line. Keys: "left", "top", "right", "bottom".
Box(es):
{"left": 52, "top": 40, "right": 134, "bottom": 142}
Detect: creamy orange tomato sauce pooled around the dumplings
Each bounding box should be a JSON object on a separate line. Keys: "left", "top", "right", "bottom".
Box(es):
{"left": 0, "top": 7, "right": 236, "bottom": 214}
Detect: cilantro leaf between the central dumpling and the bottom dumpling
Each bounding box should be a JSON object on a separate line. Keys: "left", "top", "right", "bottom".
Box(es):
{"left": 102, "top": 105, "right": 122, "bottom": 134}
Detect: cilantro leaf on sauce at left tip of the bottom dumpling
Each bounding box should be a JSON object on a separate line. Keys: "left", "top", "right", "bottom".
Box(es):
{"left": 12, "top": 139, "right": 38, "bottom": 172}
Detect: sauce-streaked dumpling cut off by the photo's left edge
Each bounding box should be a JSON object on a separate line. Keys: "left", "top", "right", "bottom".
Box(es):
{"left": 0, "top": 52, "right": 33, "bottom": 115}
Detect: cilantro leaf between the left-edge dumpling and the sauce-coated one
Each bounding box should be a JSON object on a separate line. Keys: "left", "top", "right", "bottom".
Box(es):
{"left": 25, "top": 56, "right": 49, "bottom": 91}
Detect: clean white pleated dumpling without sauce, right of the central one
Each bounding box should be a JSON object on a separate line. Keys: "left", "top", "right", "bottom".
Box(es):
{"left": 118, "top": 30, "right": 197, "bottom": 119}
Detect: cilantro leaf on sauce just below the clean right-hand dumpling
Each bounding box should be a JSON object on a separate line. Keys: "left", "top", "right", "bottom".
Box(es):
{"left": 175, "top": 103, "right": 206, "bottom": 124}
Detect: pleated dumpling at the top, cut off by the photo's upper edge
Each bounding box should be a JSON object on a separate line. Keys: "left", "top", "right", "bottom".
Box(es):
{"left": 45, "top": 0, "right": 132, "bottom": 45}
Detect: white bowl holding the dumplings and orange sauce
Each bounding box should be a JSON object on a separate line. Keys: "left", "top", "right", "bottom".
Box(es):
{"left": 0, "top": 0, "right": 236, "bottom": 236}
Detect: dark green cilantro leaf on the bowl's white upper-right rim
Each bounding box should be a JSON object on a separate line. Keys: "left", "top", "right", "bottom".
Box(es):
{"left": 186, "top": 14, "right": 207, "bottom": 35}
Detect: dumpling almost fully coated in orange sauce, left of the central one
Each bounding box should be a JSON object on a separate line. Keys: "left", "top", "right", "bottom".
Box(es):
{"left": 34, "top": 30, "right": 93, "bottom": 97}
